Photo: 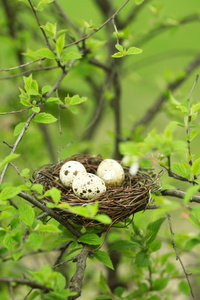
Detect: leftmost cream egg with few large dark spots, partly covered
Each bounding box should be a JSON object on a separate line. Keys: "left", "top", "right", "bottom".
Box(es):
{"left": 60, "top": 160, "right": 87, "bottom": 187}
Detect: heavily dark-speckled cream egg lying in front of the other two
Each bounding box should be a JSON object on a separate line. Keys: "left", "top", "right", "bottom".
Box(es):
{"left": 72, "top": 173, "right": 106, "bottom": 199}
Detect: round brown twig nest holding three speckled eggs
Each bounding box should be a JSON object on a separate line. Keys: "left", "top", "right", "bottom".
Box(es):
{"left": 33, "top": 155, "right": 160, "bottom": 227}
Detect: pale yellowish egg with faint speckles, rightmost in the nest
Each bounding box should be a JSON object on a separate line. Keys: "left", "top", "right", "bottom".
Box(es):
{"left": 97, "top": 159, "right": 125, "bottom": 187}
